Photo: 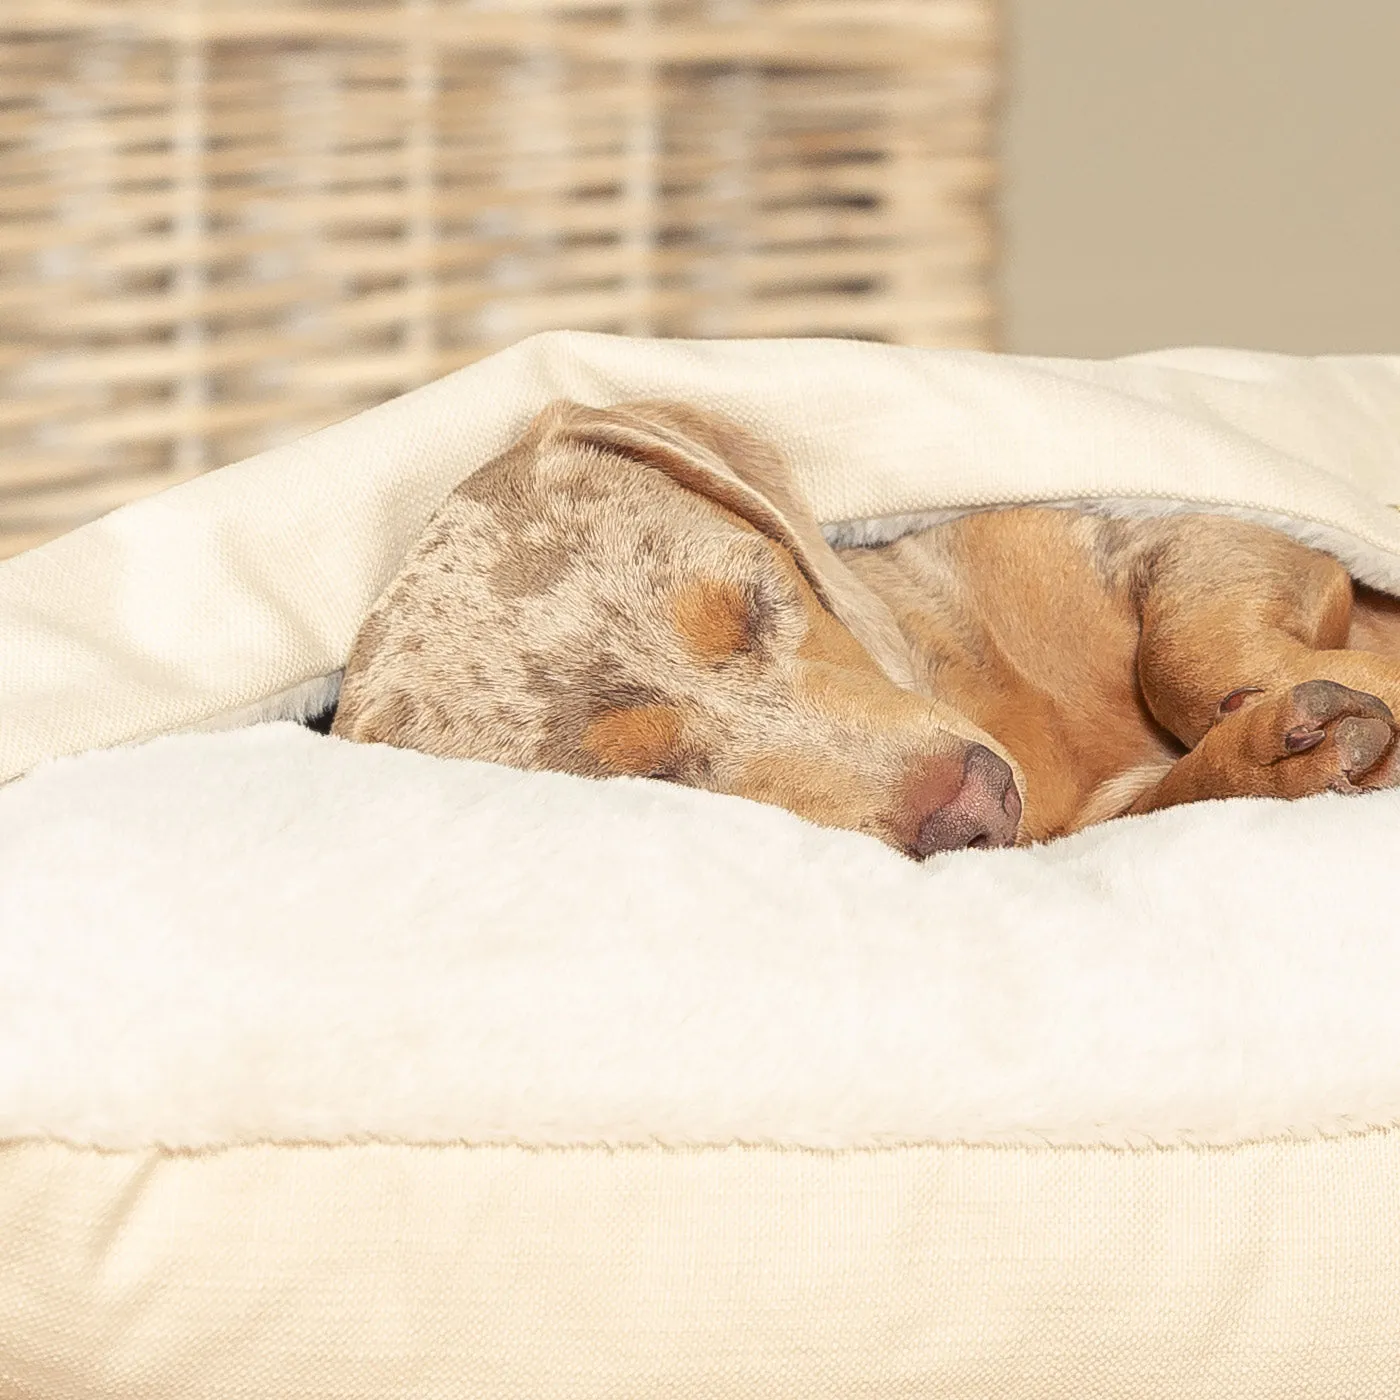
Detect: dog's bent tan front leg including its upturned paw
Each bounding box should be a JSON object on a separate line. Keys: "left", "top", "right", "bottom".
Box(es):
{"left": 1130, "top": 515, "right": 1400, "bottom": 812}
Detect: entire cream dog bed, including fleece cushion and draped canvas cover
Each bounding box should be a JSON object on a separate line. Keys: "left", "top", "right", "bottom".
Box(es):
{"left": 0, "top": 335, "right": 1400, "bottom": 1400}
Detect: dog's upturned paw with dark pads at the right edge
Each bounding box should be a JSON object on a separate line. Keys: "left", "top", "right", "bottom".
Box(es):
{"left": 1212, "top": 680, "right": 1400, "bottom": 798}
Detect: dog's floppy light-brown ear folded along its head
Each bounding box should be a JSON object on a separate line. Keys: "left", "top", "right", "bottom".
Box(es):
{"left": 536, "top": 400, "right": 913, "bottom": 687}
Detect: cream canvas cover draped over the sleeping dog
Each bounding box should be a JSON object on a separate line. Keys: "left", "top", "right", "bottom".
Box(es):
{"left": 0, "top": 333, "right": 1400, "bottom": 781}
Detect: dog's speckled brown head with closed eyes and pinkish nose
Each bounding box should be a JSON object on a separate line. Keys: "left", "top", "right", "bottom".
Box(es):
{"left": 333, "top": 403, "right": 1021, "bottom": 857}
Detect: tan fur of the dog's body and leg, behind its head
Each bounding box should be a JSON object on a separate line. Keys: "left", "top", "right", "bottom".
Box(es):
{"left": 846, "top": 508, "right": 1400, "bottom": 840}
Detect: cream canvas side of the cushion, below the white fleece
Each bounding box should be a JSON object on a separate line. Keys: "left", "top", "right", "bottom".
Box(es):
{"left": 0, "top": 1133, "right": 1400, "bottom": 1400}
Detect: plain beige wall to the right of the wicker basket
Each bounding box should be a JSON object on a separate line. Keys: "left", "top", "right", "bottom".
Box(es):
{"left": 1001, "top": 0, "right": 1400, "bottom": 356}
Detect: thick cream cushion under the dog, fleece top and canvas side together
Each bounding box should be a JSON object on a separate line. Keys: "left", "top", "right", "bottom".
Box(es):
{"left": 8, "top": 724, "right": 1400, "bottom": 1400}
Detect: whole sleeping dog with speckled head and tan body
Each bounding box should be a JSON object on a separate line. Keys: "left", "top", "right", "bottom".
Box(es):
{"left": 322, "top": 402, "right": 1400, "bottom": 858}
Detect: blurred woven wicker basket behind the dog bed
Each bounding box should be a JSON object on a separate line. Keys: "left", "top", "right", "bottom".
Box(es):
{"left": 0, "top": 0, "right": 995, "bottom": 554}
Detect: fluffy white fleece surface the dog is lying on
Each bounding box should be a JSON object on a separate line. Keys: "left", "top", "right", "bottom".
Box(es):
{"left": 0, "top": 724, "right": 1400, "bottom": 1148}
